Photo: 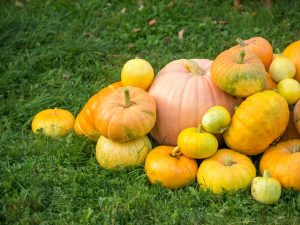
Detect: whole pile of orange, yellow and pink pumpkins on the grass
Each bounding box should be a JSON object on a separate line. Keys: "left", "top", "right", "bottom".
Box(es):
{"left": 32, "top": 37, "right": 300, "bottom": 204}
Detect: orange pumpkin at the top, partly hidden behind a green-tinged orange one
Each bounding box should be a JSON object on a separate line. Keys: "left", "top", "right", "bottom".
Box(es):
{"left": 230, "top": 37, "right": 273, "bottom": 70}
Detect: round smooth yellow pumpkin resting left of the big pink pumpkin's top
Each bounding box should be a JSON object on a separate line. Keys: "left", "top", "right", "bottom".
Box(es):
{"left": 121, "top": 58, "right": 154, "bottom": 90}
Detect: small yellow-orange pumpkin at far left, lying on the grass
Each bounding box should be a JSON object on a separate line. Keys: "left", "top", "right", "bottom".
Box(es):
{"left": 31, "top": 108, "right": 75, "bottom": 138}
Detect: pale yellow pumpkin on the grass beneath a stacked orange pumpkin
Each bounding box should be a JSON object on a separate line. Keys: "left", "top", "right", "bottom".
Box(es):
{"left": 96, "top": 136, "right": 152, "bottom": 170}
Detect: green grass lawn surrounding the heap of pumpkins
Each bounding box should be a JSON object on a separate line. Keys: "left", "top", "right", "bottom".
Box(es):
{"left": 0, "top": 0, "right": 300, "bottom": 225}
